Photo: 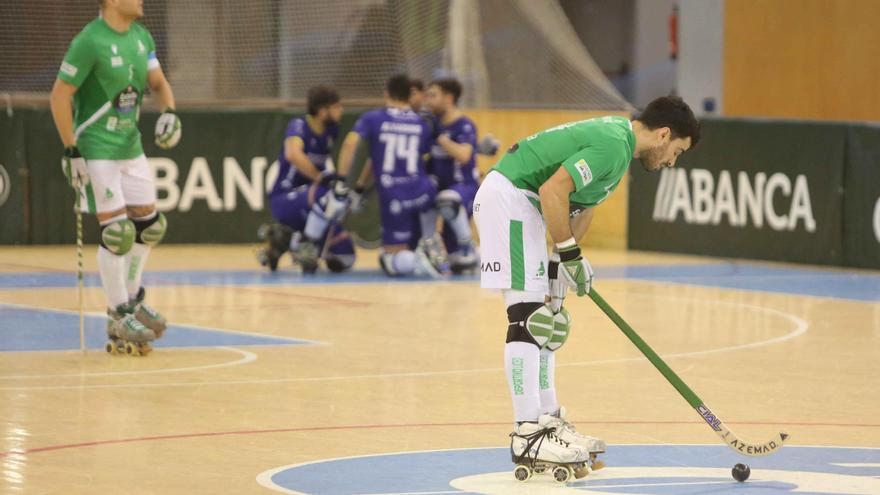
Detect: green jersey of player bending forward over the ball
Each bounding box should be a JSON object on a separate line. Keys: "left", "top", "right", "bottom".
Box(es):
{"left": 493, "top": 117, "right": 636, "bottom": 208}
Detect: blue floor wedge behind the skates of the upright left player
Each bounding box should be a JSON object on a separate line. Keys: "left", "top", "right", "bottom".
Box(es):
{"left": 0, "top": 304, "right": 314, "bottom": 352}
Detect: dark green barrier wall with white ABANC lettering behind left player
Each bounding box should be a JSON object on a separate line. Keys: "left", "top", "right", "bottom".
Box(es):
{"left": 0, "top": 109, "right": 378, "bottom": 244}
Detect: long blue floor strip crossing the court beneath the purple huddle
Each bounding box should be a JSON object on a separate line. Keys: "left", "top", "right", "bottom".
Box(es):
{"left": 0, "top": 263, "right": 880, "bottom": 302}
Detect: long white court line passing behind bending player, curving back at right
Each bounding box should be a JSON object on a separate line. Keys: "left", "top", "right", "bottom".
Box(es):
{"left": 0, "top": 294, "right": 809, "bottom": 391}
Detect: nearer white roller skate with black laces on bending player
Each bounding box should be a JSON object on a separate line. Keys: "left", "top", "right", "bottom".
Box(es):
{"left": 510, "top": 414, "right": 590, "bottom": 483}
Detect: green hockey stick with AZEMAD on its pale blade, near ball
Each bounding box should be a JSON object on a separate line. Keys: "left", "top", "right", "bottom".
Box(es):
{"left": 589, "top": 288, "right": 788, "bottom": 457}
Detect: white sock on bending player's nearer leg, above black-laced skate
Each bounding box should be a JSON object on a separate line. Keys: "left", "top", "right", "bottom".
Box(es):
{"left": 504, "top": 342, "right": 541, "bottom": 422}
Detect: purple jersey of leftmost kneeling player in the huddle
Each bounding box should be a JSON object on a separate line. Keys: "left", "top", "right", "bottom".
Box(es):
{"left": 269, "top": 117, "right": 339, "bottom": 196}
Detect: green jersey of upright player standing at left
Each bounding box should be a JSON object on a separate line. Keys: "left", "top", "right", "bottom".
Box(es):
{"left": 58, "top": 18, "right": 159, "bottom": 160}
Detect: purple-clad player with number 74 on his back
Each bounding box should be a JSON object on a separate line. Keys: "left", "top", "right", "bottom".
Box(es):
{"left": 339, "top": 75, "right": 445, "bottom": 276}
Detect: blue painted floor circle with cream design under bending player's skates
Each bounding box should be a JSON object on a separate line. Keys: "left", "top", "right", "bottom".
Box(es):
{"left": 263, "top": 445, "right": 880, "bottom": 495}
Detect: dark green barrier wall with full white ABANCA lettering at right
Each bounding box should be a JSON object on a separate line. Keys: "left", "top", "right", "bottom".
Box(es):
{"left": 628, "top": 119, "right": 880, "bottom": 267}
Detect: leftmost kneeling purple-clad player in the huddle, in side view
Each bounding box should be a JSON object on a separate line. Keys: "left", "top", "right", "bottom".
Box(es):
{"left": 259, "top": 86, "right": 354, "bottom": 272}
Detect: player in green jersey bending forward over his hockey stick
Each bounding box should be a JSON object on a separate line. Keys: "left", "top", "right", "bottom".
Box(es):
{"left": 474, "top": 97, "right": 700, "bottom": 476}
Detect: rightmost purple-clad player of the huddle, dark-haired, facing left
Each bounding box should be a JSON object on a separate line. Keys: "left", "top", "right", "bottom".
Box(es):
{"left": 427, "top": 79, "right": 479, "bottom": 273}
